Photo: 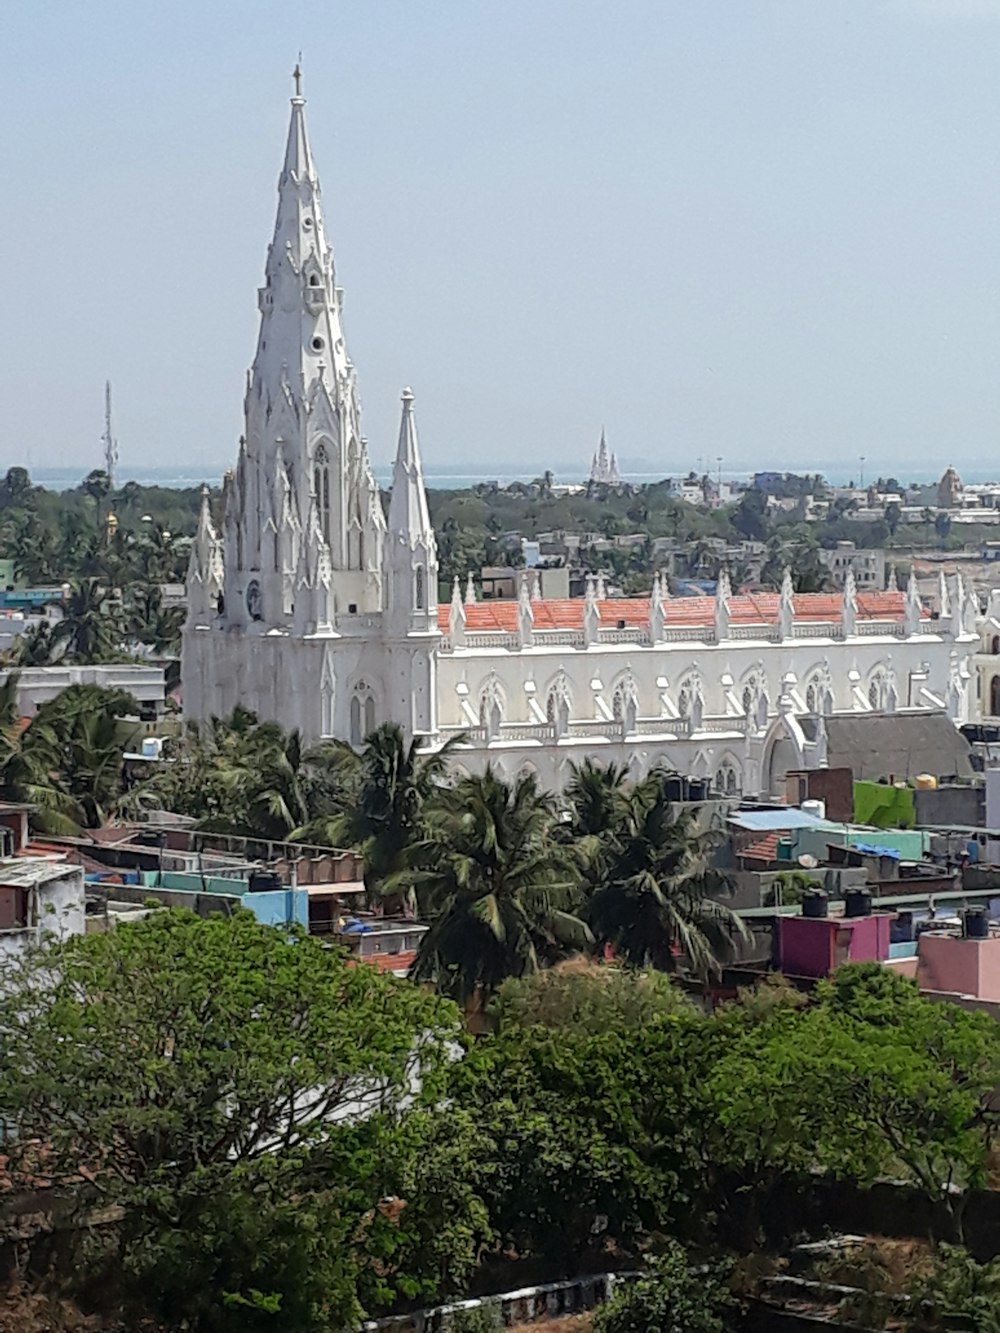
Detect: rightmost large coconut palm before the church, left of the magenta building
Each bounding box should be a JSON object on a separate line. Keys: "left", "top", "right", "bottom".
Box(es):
{"left": 587, "top": 774, "right": 748, "bottom": 976}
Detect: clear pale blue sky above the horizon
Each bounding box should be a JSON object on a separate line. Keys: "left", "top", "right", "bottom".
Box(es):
{"left": 0, "top": 0, "right": 1000, "bottom": 475}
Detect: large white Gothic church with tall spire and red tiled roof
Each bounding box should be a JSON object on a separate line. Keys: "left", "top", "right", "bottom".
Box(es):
{"left": 183, "top": 83, "right": 980, "bottom": 794}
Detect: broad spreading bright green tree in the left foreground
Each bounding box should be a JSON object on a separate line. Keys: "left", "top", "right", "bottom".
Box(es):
{"left": 0, "top": 912, "right": 483, "bottom": 1333}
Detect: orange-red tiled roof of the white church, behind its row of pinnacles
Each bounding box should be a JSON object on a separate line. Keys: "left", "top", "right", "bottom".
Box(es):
{"left": 437, "top": 592, "right": 927, "bottom": 635}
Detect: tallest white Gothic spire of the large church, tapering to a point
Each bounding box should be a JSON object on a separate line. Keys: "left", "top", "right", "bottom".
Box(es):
{"left": 225, "top": 68, "right": 385, "bottom": 627}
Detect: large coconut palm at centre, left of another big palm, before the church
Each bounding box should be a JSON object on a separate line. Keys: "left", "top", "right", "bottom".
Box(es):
{"left": 411, "top": 768, "right": 592, "bottom": 1004}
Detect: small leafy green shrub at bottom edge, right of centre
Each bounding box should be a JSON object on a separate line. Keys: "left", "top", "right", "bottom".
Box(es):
{"left": 593, "top": 1240, "right": 736, "bottom": 1333}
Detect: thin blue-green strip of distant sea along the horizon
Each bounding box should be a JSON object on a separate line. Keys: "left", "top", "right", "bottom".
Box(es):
{"left": 17, "top": 460, "right": 1000, "bottom": 491}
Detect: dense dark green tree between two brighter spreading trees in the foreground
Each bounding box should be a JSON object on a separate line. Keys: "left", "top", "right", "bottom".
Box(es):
{"left": 455, "top": 1008, "right": 705, "bottom": 1270}
